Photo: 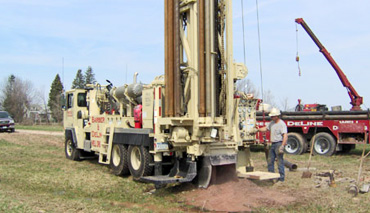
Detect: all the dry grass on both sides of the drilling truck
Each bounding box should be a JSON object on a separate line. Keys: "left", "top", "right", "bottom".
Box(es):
{"left": 0, "top": 133, "right": 370, "bottom": 212}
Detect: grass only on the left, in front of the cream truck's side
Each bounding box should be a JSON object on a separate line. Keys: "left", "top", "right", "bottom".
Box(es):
{"left": 0, "top": 133, "right": 185, "bottom": 212}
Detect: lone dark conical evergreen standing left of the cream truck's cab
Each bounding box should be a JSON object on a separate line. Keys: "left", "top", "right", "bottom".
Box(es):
{"left": 48, "top": 74, "right": 63, "bottom": 122}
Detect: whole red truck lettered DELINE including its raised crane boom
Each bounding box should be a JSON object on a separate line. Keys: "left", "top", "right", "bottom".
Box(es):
{"left": 257, "top": 18, "right": 370, "bottom": 156}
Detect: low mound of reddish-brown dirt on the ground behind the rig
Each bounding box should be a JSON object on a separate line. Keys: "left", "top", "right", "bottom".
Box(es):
{"left": 185, "top": 179, "right": 296, "bottom": 212}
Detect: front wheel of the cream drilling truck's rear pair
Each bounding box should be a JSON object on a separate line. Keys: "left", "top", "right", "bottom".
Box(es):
{"left": 110, "top": 144, "right": 129, "bottom": 175}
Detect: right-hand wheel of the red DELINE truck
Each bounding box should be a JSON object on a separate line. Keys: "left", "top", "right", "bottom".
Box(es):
{"left": 311, "top": 132, "right": 337, "bottom": 156}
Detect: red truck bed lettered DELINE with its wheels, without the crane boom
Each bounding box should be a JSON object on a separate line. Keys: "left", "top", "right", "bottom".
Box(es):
{"left": 257, "top": 111, "right": 370, "bottom": 156}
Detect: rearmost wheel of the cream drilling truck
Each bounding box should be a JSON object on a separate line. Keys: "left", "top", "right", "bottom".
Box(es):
{"left": 128, "top": 145, "right": 153, "bottom": 180}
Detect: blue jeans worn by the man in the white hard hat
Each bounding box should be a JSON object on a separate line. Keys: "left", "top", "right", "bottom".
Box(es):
{"left": 267, "top": 142, "right": 285, "bottom": 182}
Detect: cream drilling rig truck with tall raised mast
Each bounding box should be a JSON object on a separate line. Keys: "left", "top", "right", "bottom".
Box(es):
{"left": 64, "top": 0, "right": 257, "bottom": 187}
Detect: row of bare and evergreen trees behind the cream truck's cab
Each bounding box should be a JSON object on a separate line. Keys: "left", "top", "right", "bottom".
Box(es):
{"left": 0, "top": 66, "right": 96, "bottom": 123}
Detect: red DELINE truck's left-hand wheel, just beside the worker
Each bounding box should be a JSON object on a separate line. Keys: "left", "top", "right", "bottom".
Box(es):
{"left": 285, "top": 132, "right": 308, "bottom": 155}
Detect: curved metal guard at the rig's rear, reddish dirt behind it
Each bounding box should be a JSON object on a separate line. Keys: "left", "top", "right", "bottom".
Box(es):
{"left": 197, "top": 155, "right": 236, "bottom": 188}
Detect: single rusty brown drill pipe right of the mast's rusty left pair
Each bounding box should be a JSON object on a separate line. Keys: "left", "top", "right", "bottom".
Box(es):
{"left": 198, "top": 0, "right": 206, "bottom": 117}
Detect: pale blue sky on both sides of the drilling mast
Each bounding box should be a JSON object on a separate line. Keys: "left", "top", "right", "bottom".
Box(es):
{"left": 0, "top": 0, "right": 370, "bottom": 109}
